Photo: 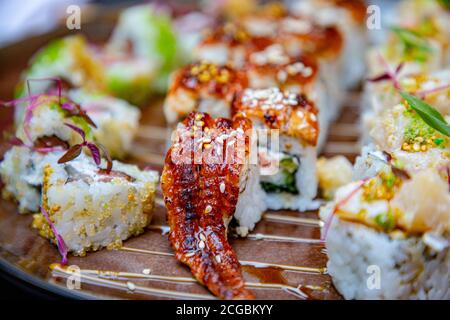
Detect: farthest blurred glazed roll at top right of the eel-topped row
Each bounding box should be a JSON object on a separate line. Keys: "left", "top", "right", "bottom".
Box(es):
{"left": 291, "top": 0, "right": 367, "bottom": 89}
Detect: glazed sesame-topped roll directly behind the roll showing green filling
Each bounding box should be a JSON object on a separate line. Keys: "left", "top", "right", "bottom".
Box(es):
{"left": 245, "top": 44, "right": 336, "bottom": 150}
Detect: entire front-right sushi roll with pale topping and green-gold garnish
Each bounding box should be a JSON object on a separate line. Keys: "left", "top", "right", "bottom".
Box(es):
{"left": 320, "top": 168, "right": 450, "bottom": 300}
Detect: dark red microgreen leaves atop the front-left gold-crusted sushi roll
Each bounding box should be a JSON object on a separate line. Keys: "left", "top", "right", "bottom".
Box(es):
{"left": 58, "top": 123, "right": 112, "bottom": 173}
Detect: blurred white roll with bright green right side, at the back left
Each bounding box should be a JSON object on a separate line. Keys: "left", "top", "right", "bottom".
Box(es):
{"left": 105, "top": 4, "right": 180, "bottom": 95}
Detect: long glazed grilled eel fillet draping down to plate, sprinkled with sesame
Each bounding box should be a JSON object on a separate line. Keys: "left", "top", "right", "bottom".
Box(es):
{"left": 161, "top": 112, "right": 254, "bottom": 299}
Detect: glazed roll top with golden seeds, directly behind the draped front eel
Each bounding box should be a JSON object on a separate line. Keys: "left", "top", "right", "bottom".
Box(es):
{"left": 164, "top": 61, "right": 247, "bottom": 124}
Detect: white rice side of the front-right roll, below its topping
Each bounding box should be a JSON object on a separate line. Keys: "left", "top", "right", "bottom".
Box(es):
{"left": 321, "top": 206, "right": 450, "bottom": 299}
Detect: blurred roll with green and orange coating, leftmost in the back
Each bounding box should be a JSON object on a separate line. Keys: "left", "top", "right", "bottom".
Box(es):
{"left": 16, "top": 35, "right": 105, "bottom": 100}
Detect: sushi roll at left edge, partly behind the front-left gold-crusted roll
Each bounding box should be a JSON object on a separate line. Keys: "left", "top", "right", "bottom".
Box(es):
{"left": 0, "top": 95, "right": 93, "bottom": 213}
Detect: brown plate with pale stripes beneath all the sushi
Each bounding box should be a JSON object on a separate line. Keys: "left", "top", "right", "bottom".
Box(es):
{"left": 0, "top": 5, "right": 359, "bottom": 299}
